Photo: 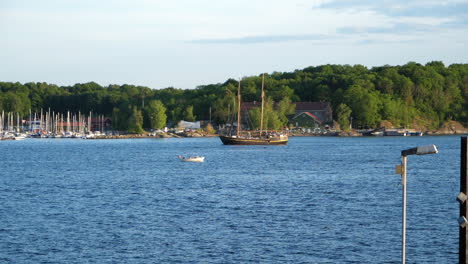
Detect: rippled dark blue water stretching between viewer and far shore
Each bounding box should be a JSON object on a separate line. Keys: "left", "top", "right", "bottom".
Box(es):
{"left": 0, "top": 137, "right": 460, "bottom": 263}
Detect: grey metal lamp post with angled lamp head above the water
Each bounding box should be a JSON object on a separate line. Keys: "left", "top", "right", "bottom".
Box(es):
{"left": 396, "top": 145, "right": 437, "bottom": 264}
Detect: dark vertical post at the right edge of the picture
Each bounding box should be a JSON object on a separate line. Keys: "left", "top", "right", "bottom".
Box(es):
{"left": 458, "top": 137, "right": 468, "bottom": 264}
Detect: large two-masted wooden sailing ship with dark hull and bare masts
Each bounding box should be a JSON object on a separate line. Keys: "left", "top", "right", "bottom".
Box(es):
{"left": 219, "top": 75, "right": 288, "bottom": 145}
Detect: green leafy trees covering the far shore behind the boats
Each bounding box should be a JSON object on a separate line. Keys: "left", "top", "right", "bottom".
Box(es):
{"left": 0, "top": 61, "right": 468, "bottom": 131}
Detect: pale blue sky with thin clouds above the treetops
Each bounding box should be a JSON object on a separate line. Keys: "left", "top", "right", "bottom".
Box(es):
{"left": 0, "top": 0, "right": 468, "bottom": 89}
